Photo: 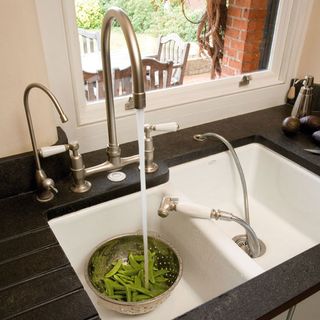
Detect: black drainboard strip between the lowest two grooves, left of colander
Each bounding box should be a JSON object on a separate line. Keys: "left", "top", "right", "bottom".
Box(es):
{"left": 0, "top": 267, "right": 82, "bottom": 319}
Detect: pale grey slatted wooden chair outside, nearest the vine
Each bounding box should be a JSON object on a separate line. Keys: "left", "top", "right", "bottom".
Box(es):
{"left": 155, "top": 33, "right": 190, "bottom": 85}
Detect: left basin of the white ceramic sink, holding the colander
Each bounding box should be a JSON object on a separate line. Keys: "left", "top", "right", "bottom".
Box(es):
{"left": 49, "top": 184, "right": 263, "bottom": 320}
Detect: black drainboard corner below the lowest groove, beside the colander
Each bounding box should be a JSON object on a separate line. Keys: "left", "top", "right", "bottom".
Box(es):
{"left": 11, "top": 290, "right": 100, "bottom": 320}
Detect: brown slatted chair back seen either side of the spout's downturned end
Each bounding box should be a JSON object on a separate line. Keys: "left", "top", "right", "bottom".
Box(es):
{"left": 114, "top": 58, "right": 173, "bottom": 96}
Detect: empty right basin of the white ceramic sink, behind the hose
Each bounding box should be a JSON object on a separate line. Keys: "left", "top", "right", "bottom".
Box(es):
{"left": 170, "top": 142, "right": 320, "bottom": 270}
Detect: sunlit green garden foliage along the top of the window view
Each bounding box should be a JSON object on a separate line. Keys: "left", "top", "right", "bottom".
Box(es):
{"left": 76, "top": 0, "right": 201, "bottom": 41}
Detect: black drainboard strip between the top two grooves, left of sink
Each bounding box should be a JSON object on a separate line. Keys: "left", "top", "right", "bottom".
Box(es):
{"left": 0, "top": 227, "right": 57, "bottom": 264}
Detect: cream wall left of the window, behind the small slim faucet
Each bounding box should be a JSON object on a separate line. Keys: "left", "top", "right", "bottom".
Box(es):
{"left": 0, "top": 0, "right": 57, "bottom": 157}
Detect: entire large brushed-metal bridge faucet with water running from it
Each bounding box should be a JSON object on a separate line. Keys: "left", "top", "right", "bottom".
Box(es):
{"left": 70, "top": 7, "right": 179, "bottom": 193}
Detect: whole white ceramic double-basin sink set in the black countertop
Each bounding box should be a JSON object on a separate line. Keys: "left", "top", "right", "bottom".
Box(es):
{"left": 49, "top": 142, "right": 320, "bottom": 319}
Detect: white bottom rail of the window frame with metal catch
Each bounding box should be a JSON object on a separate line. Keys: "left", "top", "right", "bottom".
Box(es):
{"left": 78, "top": 71, "right": 284, "bottom": 126}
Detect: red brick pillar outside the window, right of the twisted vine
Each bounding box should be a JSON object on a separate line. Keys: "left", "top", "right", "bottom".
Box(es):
{"left": 222, "top": 0, "right": 268, "bottom": 77}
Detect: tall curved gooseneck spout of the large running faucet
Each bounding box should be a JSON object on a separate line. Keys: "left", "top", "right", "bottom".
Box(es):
{"left": 101, "top": 7, "right": 146, "bottom": 166}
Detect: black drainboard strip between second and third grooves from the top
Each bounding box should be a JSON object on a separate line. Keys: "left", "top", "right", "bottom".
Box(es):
{"left": 0, "top": 245, "right": 69, "bottom": 290}
